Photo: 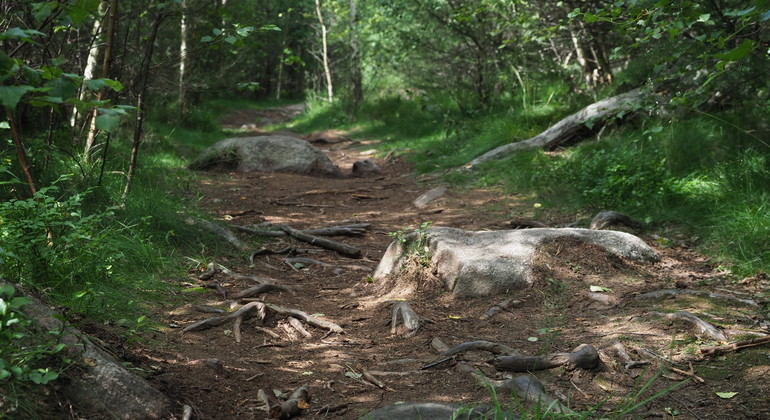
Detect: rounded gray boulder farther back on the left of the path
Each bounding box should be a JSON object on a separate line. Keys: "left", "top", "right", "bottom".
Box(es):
{"left": 189, "top": 136, "right": 340, "bottom": 176}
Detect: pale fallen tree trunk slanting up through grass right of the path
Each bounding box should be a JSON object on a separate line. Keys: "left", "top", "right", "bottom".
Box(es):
{"left": 465, "top": 89, "right": 642, "bottom": 169}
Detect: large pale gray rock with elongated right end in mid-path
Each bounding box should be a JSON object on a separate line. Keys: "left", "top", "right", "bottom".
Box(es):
{"left": 372, "top": 227, "right": 660, "bottom": 297}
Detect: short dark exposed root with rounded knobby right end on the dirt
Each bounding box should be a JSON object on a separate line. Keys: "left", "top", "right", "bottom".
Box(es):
{"left": 492, "top": 344, "right": 601, "bottom": 372}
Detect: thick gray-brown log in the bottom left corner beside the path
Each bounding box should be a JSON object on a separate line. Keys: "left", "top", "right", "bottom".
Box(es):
{"left": 9, "top": 281, "right": 174, "bottom": 419}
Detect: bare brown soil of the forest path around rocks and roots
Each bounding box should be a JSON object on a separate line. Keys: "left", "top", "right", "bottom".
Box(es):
{"left": 121, "top": 106, "right": 770, "bottom": 419}
